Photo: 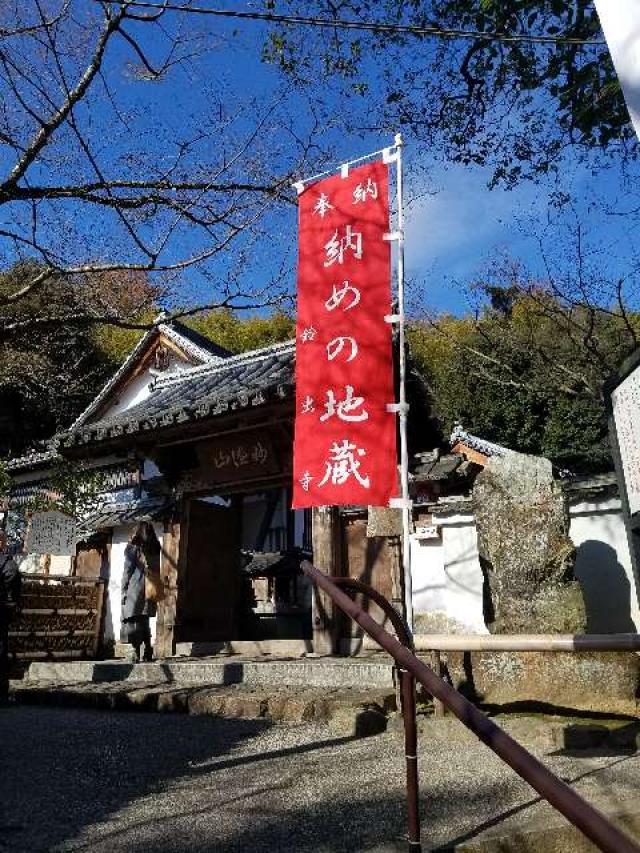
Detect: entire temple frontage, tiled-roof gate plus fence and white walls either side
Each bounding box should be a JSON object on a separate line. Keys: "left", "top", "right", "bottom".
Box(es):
{"left": 8, "top": 322, "right": 640, "bottom": 659}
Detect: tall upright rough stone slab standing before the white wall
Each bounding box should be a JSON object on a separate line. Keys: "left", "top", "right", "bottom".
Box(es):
{"left": 473, "top": 451, "right": 586, "bottom": 634}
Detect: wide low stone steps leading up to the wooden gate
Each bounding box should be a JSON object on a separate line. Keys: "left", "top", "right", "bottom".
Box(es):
{"left": 12, "top": 658, "right": 397, "bottom": 736}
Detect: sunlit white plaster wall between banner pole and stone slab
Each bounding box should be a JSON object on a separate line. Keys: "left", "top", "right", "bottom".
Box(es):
{"left": 411, "top": 513, "right": 488, "bottom": 634}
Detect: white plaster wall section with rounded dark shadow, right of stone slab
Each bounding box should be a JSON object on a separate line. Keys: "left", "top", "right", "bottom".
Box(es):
{"left": 569, "top": 498, "right": 640, "bottom": 634}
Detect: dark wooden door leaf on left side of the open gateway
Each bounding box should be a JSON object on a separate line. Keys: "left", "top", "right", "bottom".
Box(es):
{"left": 178, "top": 499, "right": 240, "bottom": 642}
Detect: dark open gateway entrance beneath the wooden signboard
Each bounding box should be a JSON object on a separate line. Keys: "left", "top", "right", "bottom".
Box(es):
{"left": 176, "top": 488, "right": 312, "bottom": 643}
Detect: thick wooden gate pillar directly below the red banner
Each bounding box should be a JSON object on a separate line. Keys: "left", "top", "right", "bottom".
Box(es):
{"left": 311, "top": 506, "right": 342, "bottom": 655}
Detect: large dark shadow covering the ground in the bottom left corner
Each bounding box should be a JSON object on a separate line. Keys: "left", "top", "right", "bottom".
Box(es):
{"left": 0, "top": 706, "right": 269, "bottom": 853}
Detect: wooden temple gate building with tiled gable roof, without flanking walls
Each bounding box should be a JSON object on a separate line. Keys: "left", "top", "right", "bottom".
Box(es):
{"left": 7, "top": 322, "right": 433, "bottom": 657}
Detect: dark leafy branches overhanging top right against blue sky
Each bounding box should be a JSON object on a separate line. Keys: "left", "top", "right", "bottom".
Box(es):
{"left": 264, "top": 0, "right": 637, "bottom": 185}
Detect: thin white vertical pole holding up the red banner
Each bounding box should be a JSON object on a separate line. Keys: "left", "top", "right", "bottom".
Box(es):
{"left": 395, "top": 133, "right": 413, "bottom": 631}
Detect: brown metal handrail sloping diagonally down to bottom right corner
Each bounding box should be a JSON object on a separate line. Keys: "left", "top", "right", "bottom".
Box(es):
{"left": 302, "top": 562, "right": 640, "bottom": 853}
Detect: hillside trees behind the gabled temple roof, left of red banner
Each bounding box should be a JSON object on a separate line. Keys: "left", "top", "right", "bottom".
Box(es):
{"left": 0, "top": 262, "right": 294, "bottom": 455}
